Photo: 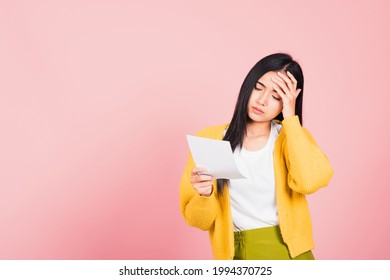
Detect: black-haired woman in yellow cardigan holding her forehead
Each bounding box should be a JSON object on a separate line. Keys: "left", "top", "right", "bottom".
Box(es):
{"left": 180, "top": 53, "right": 333, "bottom": 259}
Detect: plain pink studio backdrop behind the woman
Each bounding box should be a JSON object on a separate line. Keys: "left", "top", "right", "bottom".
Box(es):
{"left": 0, "top": 0, "right": 390, "bottom": 259}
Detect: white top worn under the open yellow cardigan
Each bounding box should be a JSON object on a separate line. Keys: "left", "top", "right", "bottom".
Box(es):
{"left": 229, "top": 122, "right": 281, "bottom": 231}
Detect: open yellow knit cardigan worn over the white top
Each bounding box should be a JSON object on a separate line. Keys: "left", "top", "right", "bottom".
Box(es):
{"left": 180, "top": 116, "right": 333, "bottom": 259}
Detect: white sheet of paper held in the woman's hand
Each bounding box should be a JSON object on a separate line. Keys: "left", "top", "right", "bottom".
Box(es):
{"left": 187, "top": 135, "right": 246, "bottom": 179}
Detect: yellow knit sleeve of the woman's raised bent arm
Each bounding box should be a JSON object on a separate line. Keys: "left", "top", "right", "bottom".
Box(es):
{"left": 283, "top": 116, "right": 334, "bottom": 194}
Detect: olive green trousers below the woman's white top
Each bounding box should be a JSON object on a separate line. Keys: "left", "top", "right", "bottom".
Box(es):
{"left": 234, "top": 226, "right": 314, "bottom": 260}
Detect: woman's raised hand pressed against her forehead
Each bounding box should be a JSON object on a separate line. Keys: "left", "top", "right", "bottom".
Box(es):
{"left": 272, "top": 71, "right": 301, "bottom": 118}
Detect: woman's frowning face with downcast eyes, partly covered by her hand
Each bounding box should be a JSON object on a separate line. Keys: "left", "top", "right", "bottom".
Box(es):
{"left": 247, "top": 71, "right": 283, "bottom": 122}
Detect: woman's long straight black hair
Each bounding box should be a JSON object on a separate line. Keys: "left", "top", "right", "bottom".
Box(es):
{"left": 217, "top": 53, "right": 303, "bottom": 195}
